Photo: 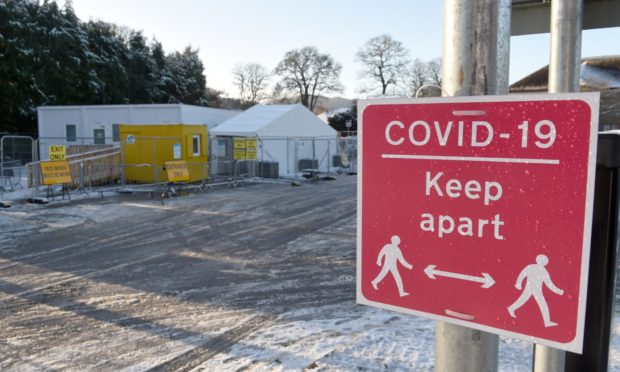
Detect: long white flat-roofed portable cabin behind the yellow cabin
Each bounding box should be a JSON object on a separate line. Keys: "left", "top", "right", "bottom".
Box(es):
{"left": 37, "top": 104, "right": 239, "bottom": 159}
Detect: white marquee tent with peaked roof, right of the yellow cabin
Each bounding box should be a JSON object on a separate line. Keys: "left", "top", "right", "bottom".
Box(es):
{"left": 210, "top": 104, "right": 338, "bottom": 177}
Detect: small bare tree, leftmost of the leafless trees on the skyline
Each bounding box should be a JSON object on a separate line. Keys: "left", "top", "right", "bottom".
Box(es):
{"left": 232, "top": 63, "right": 270, "bottom": 107}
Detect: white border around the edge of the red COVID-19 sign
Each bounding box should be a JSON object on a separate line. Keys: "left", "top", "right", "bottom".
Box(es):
{"left": 356, "top": 92, "right": 600, "bottom": 354}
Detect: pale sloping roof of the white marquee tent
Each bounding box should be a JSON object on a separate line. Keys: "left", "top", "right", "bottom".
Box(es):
{"left": 211, "top": 104, "right": 337, "bottom": 138}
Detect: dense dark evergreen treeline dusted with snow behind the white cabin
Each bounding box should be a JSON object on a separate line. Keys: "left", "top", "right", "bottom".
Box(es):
{"left": 0, "top": 0, "right": 220, "bottom": 133}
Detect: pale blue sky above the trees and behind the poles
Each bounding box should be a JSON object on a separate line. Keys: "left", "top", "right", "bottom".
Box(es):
{"left": 65, "top": 0, "right": 620, "bottom": 98}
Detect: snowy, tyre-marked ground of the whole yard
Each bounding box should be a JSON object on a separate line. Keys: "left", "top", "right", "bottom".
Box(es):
{"left": 0, "top": 177, "right": 620, "bottom": 371}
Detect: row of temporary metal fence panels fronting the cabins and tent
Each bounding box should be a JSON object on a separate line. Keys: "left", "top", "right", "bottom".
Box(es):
{"left": 0, "top": 132, "right": 357, "bottom": 196}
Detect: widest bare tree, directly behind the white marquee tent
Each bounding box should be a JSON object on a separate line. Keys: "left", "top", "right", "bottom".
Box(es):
{"left": 275, "top": 46, "right": 342, "bottom": 111}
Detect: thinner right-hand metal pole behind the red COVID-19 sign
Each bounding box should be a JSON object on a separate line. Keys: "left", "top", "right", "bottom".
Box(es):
{"left": 533, "top": 0, "right": 583, "bottom": 372}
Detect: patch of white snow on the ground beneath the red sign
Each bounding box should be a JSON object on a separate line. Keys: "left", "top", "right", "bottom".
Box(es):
{"left": 196, "top": 303, "right": 620, "bottom": 372}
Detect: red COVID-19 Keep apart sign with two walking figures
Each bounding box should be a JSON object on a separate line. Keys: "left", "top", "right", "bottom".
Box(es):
{"left": 357, "top": 93, "right": 598, "bottom": 353}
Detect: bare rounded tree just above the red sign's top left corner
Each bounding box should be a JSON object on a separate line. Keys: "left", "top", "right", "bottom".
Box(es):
{"left": 355, "top": 35, "right": 409, "bottom": 94}
